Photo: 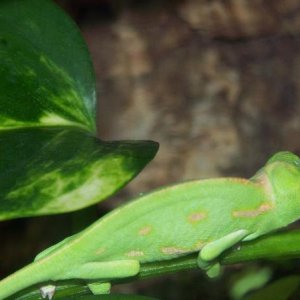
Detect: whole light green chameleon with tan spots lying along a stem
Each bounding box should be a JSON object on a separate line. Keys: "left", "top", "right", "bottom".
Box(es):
{"left": 0, "top": 152, "right": 300, "bottom": 299}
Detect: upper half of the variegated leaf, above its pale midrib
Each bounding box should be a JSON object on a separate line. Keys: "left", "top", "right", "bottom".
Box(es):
{"left": 0, "top": 0, "right": 95, "bottom": 131}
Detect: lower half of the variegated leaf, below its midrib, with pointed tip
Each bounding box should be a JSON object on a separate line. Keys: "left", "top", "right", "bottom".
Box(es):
{"left": 0, "top": 127, "right": 157, "bottom": 220}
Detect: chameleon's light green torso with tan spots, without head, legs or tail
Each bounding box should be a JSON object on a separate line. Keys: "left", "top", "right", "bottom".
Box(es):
{"left": 57, "top": 178, "right": 275, "bottom": 263}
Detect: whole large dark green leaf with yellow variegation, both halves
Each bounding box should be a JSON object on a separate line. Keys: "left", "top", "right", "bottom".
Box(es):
{"left": 0, "top": 0, "right": 158, "bottom": 220}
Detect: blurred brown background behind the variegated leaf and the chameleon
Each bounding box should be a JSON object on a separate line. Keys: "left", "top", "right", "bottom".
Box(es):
{"left": 2, "top": 0, "right": 300, "bottom": 299}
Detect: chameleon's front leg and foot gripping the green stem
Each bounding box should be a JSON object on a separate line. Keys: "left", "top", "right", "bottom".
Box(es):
{"left": 197, "top": 229, "right": 250, "bottom": 277}
